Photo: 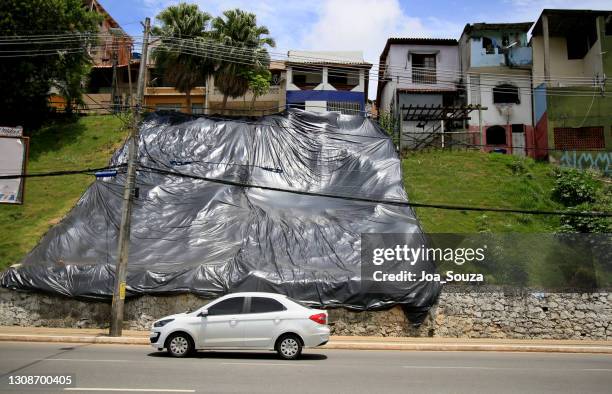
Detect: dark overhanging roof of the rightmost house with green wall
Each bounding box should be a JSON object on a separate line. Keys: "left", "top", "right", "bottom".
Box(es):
{"left": 532, "top": 9, "right": 612, "bottom": 36}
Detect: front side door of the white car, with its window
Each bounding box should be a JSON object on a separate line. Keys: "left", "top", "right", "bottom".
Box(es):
{"left": 200, "top": 297, "right": 246, "bottom": 347}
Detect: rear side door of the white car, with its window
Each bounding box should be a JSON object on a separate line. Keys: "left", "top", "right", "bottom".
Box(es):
{"left": 241, "top": 297, "right": 286, "bottom": 348}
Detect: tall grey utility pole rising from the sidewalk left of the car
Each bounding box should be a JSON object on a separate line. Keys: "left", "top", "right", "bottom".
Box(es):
{"left": 110, "top": 18, "right": 151, "bottom": 337}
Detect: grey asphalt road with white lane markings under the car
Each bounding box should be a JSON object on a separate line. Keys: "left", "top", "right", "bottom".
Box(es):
{"left": 0, "top": 342, "right": 612, "bottom": 394}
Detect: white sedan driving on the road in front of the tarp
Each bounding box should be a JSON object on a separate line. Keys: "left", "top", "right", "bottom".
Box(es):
{"left": 149, "top": 293, "right": 330, "bottom": 360}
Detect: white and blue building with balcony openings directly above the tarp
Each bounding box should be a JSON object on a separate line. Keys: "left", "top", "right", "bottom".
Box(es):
{"left": 286, "top": 51, "right": 372, "bottom": 115}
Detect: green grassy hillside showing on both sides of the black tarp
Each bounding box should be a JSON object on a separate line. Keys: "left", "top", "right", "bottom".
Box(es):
{"left": 0, "top": 116, "right": 561, "bottom": 269}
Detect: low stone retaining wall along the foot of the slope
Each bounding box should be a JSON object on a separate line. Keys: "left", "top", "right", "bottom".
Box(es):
{"left": 0, "top": 289, "right": 612, "bottom": 340}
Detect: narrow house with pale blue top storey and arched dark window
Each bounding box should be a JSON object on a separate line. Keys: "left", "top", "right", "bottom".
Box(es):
{"left": 459, "top": 22, "right": 533, "bottom": 155}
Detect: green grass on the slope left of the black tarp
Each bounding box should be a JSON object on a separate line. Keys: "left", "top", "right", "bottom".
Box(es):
{"left": 0, "top": 115, "right": 126, "bottom": 269}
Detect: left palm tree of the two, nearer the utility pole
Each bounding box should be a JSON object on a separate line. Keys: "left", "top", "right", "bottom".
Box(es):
{"left": 153, "top": 3, "right": 214, "bottom": 114}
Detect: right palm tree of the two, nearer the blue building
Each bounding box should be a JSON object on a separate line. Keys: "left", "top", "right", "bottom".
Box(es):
{"left": 212, "top": 9, "right": 276, "bottom": 112}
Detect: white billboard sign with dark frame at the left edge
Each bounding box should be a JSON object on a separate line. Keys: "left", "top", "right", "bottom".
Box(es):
{"left": 0, "top": 127, "right": 29, "bottom": 204}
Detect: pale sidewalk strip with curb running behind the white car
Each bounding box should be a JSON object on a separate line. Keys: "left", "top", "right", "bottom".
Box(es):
{"left": 0, "top": 334, "right": 612, "bottom": 354}
